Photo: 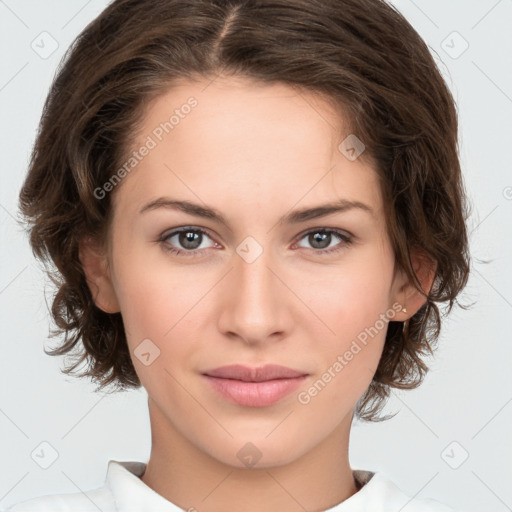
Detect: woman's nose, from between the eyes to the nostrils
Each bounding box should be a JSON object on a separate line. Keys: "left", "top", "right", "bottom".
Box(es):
{"left": 219, "top": 242, "right": 293, "bottom": 345}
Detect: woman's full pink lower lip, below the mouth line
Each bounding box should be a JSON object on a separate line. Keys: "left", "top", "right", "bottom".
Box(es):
{"left": 205, "top": 375, "right": 307, "bottom": 407}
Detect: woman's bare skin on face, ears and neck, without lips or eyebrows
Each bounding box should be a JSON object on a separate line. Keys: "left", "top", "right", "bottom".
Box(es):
{"left": 80, "top": 77, "right": 431, "bottom": 512}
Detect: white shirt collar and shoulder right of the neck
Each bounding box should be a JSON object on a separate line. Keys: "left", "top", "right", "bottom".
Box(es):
{"left": 333, "top": 470, "right": 461, "bottom": 512}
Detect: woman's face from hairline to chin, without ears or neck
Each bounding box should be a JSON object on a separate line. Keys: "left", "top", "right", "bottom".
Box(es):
{"left": 99, "top": 78, "right": 403, "bottom": 467}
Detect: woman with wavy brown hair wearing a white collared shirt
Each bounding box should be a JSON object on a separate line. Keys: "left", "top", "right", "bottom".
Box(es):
{"left": 10, "top": 0, "right": 469, "bottom": 512}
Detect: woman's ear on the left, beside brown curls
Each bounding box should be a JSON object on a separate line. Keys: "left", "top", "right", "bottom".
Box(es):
{"left": 78, "top": 237, "right": 120, "bottom": 313}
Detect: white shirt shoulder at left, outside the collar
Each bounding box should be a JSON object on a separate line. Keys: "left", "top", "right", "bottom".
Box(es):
{"left": 0, "top": 487, "right": 116, "bottom": 512}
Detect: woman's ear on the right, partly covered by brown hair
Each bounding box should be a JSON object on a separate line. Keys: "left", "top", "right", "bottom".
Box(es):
{"left": 395, "top": 249, "right": 437, "bottom": 322}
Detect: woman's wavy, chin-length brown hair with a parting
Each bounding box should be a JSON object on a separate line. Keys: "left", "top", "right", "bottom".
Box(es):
{"left": 19, "top": 0, "right": 470, "bottom": 421}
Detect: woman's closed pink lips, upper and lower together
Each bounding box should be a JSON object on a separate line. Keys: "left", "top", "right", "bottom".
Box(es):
{"left": 203, "top": 364, "right": 308, "bottom": 407}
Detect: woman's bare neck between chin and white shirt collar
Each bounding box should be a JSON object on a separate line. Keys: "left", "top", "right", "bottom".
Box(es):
{"left": 141, "top": 400, "right": 357, "bottom": 512}
